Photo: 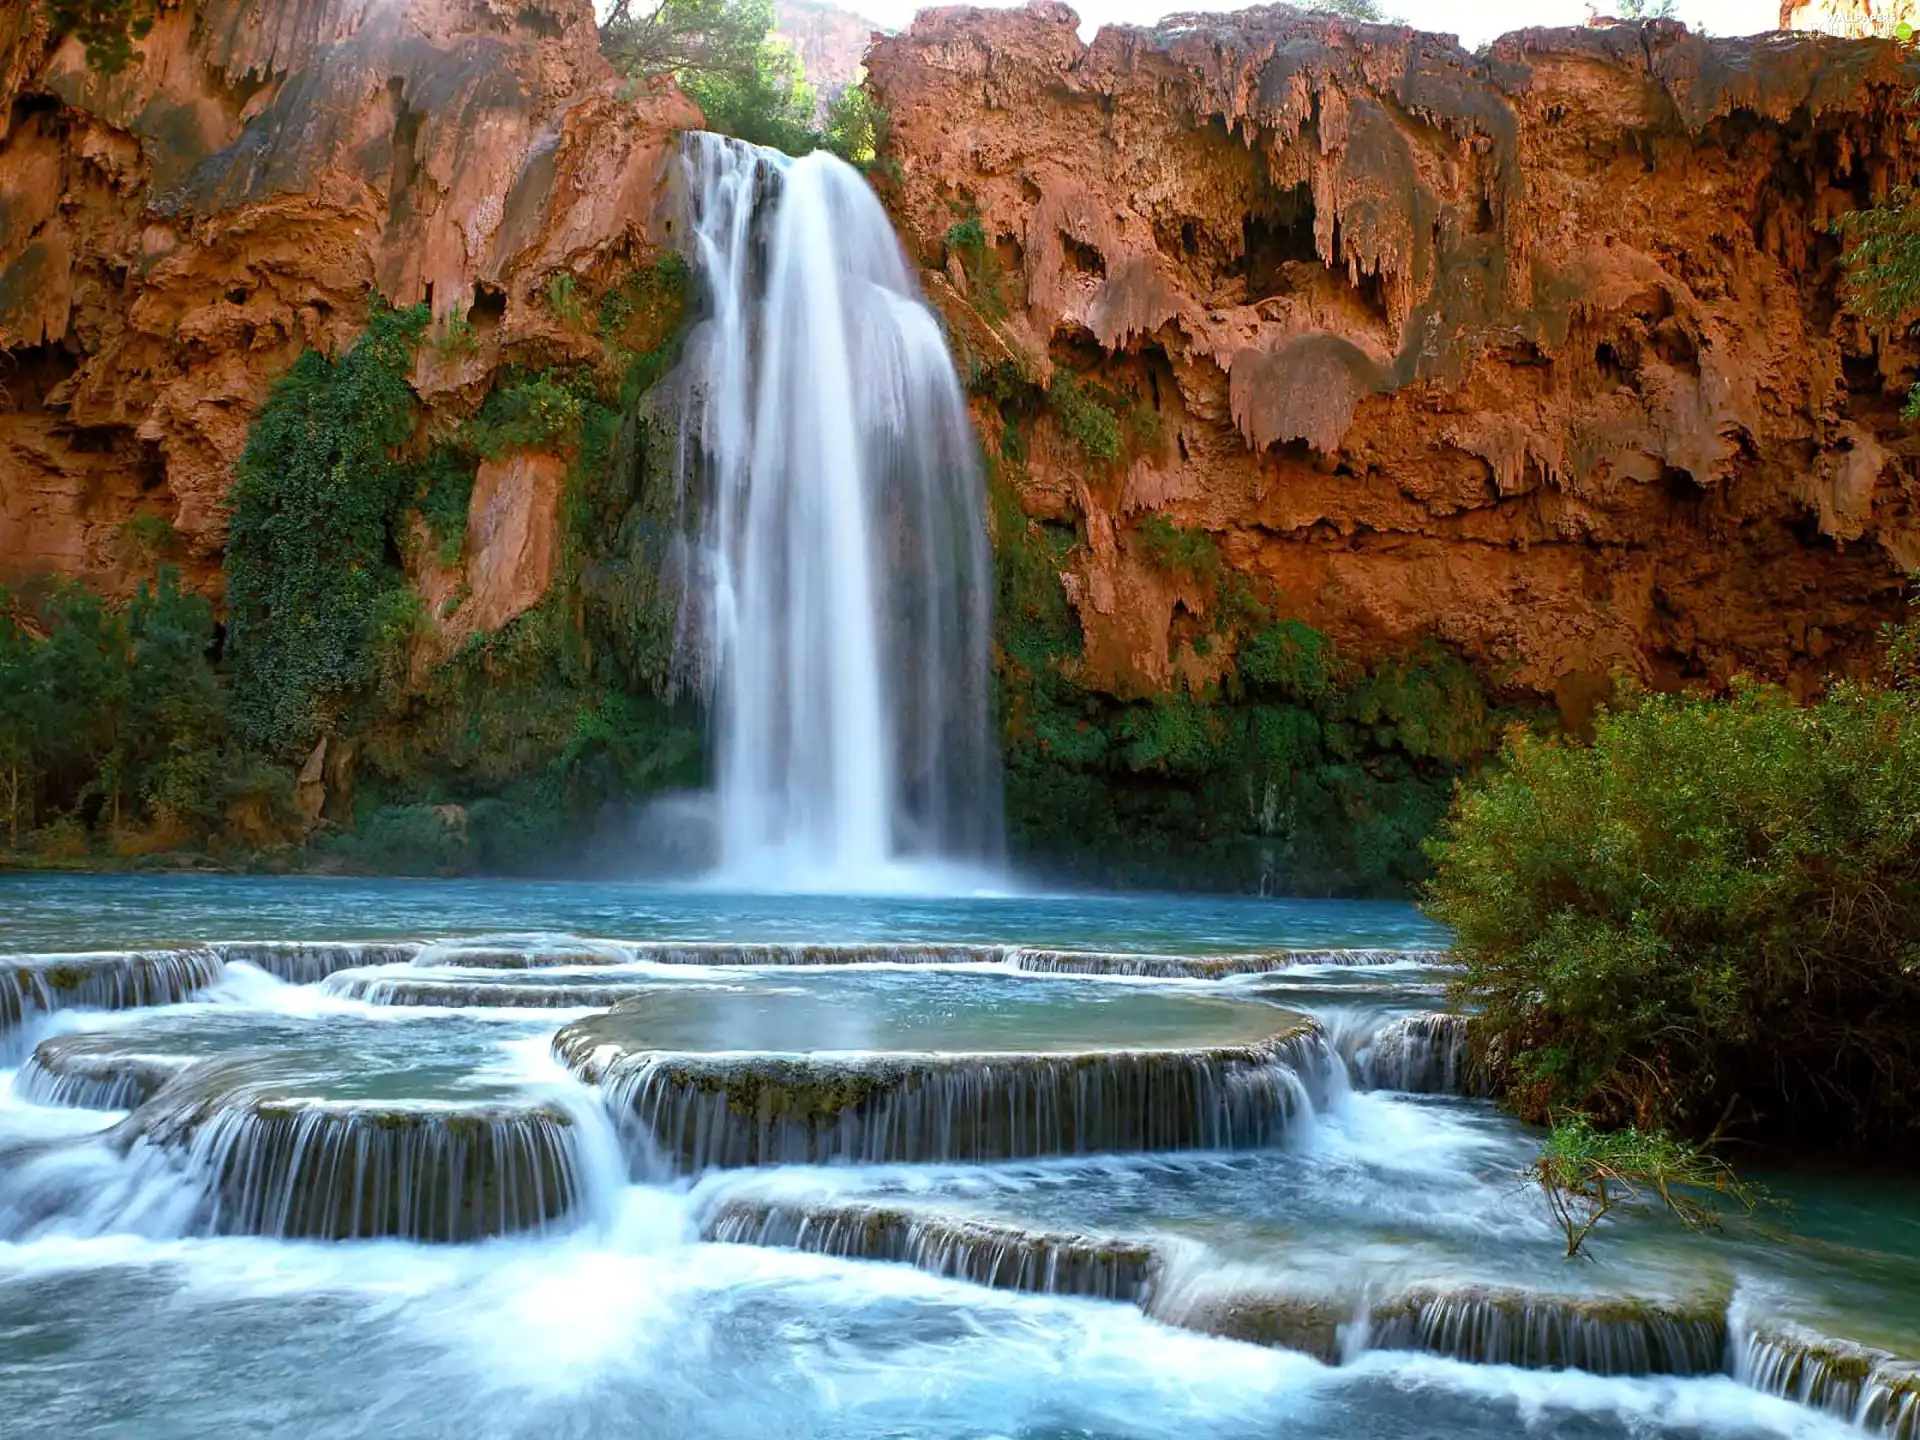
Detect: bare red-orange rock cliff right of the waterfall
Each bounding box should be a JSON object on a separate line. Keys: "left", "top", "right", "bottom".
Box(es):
{"left": 868, "top": 4, "right": 1920, "bottom": 716}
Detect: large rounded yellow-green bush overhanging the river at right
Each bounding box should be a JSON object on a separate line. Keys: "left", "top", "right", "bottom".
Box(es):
{"left": 1427, "top": 684, "right": 1920, "bottom": 1142}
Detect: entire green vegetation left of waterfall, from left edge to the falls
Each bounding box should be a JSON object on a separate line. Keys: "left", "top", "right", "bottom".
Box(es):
{"left": 0, "top": 259, "right": 703, "bottom": 872}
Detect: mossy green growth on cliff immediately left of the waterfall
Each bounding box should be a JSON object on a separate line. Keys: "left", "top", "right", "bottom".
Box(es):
{"left": 326, "top": 259, "right": 705, "bottom": 872}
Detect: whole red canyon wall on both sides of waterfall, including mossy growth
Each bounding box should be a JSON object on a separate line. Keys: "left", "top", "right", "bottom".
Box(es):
{"left": 0, "top": 0, "right": 1920, "bottom": 893}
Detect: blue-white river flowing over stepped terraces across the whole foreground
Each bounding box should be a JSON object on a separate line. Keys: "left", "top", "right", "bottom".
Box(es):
{"left": 0, "top": 876, "right": 1920, "bottom": 1440}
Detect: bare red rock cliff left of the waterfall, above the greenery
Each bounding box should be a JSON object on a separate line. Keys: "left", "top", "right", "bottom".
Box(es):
{"left": 0, "top": 0, "right": 699, "bottom": 609}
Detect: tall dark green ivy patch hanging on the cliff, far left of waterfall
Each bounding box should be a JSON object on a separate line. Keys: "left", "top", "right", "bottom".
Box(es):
{"left": 227, "top": 301, "right": 428, "bottom": 755}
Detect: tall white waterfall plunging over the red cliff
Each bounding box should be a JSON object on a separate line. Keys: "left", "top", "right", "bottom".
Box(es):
{"left": 680, "top": 134, "right": 1000, "bottom": 889}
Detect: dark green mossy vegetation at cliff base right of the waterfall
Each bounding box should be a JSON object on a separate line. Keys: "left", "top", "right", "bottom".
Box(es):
{"left": 991, "top": 416, "right": 1511, "bottom": 895}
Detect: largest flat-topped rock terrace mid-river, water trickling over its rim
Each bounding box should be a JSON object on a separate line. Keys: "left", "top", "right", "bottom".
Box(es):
{"left": 553, "top": 975, "right": 1344, "bottom": 1171}
